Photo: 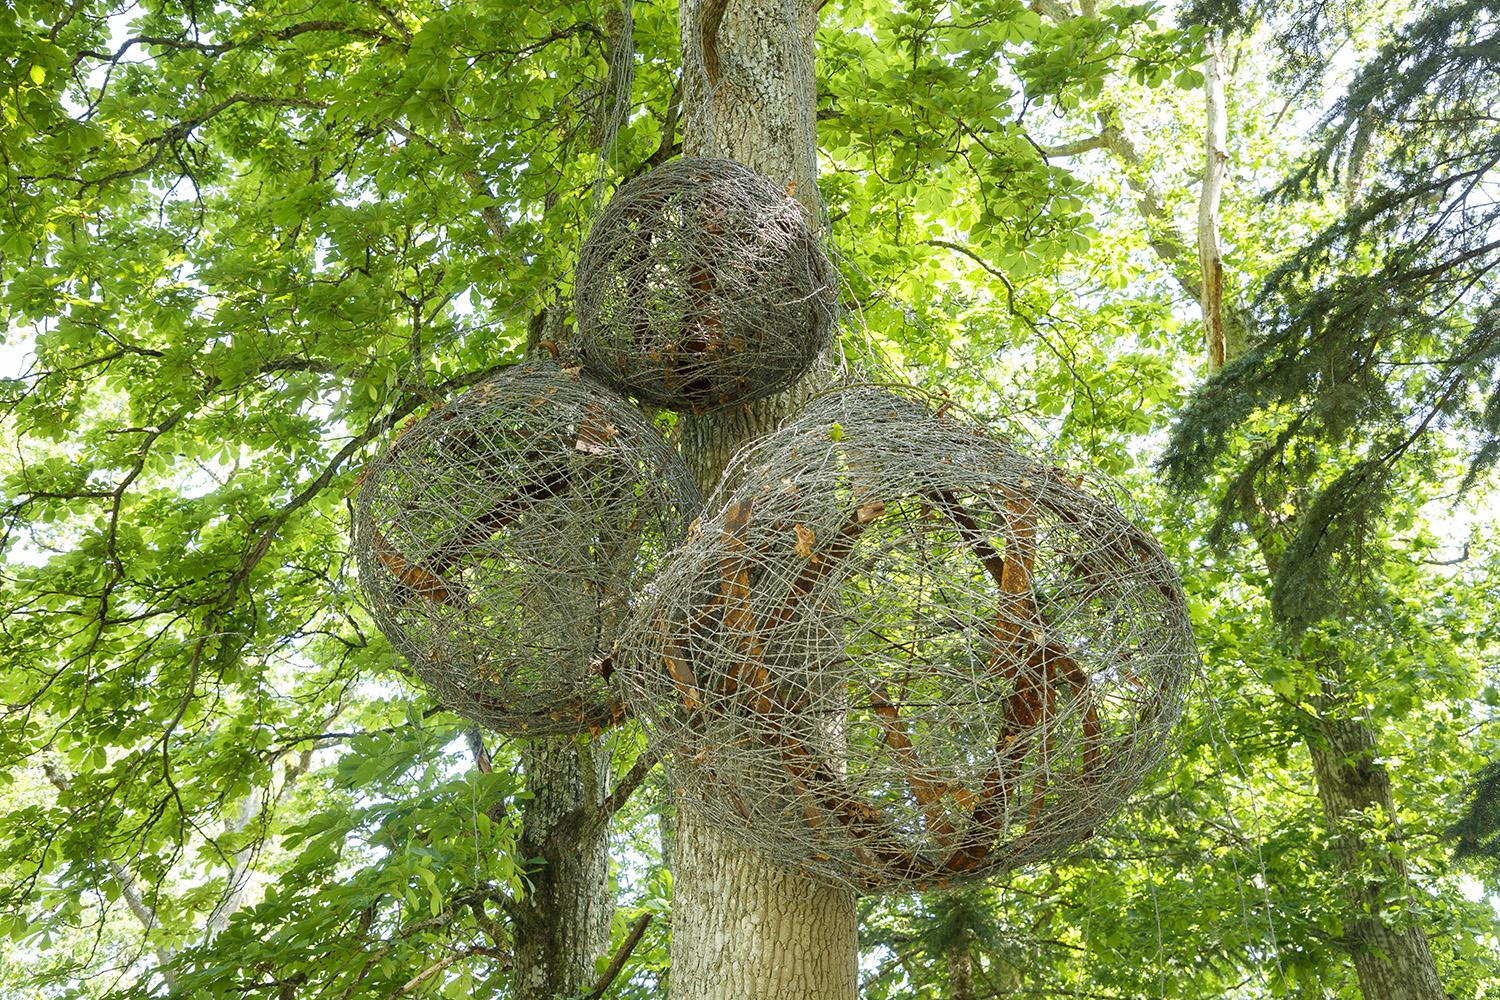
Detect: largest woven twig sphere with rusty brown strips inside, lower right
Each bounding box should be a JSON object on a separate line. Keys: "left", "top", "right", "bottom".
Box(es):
{"left": 621, "top": 388, "right": 1197, "bottom": 894}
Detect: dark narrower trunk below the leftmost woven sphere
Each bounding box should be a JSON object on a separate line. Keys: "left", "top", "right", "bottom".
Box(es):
{"left": 512, "top": 738, "right": 614, "bottom": 1000}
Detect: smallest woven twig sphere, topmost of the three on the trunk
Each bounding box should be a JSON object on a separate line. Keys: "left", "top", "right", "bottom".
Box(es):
{"left": 573, "top": 157, "right": 837, "bottom": 412}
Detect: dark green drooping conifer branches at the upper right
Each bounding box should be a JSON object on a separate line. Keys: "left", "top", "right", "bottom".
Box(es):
{"left": 1163, "top": 0, "right": 1500, "bottom": 634}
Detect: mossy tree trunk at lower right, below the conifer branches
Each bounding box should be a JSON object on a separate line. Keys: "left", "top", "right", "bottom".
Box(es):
{"left": 1308, "top": 689, "right": 1448, "bottom": 1000}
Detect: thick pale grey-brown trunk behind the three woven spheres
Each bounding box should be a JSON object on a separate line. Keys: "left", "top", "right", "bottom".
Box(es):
{"left": 671, "top": 0, "right": 858, "bottom": 1000}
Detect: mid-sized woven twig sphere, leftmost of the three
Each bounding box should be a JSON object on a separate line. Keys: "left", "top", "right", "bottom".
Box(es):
{"left": 354, "top": 363, "right": 699, "bottom": 735}
